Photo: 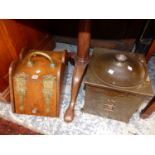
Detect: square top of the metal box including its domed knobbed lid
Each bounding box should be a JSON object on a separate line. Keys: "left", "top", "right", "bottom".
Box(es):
{"left": 85, "top": 48, "right": 153, "bottom": 96}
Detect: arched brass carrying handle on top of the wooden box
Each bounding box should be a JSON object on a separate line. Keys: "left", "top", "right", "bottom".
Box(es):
{"left": 27, "top": 51, "right": 56, "bottom": 67}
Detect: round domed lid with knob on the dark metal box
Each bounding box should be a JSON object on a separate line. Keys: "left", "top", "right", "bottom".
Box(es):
{"left": 90, "top": 52, "right": 146, "bottom": 87}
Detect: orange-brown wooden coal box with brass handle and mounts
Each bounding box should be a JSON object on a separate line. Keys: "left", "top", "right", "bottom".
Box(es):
{"left": 9, "top": 50, "right": 67, "bottom": 117}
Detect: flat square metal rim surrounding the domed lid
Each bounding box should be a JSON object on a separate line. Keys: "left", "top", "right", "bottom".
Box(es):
{"left": 84, "top": 48, "right": 154, "bottom": 97}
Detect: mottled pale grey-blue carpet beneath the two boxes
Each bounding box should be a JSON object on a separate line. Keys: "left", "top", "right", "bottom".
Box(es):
{"left": 0, "top": 43, "right": 155, "bottom": 135}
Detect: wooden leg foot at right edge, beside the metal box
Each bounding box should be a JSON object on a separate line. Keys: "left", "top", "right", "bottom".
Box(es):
{"left": 140, "top": 97, "right": 155, "bottom": 119}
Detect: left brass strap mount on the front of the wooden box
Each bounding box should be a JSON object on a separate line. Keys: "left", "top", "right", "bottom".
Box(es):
{"left": 15, "top": 73, "right": 28, "bottom": 111}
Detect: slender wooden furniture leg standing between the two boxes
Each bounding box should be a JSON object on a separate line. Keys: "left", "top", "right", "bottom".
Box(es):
{"left": 64, "top": 20, "right": 90, "bottom": 122}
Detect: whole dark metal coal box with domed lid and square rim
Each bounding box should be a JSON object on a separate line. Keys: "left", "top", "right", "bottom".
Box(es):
{"left": 83, "top": 48, "right": 153, "bottom": 122}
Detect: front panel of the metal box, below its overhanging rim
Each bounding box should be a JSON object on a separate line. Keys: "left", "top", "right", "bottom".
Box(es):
{"left": 83, "top": 85, "right": 146, "bottom": 122}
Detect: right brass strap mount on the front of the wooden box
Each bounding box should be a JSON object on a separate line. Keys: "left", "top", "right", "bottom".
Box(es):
{"left": 42, "top": 75, "right": 56, "bottom": 113}
